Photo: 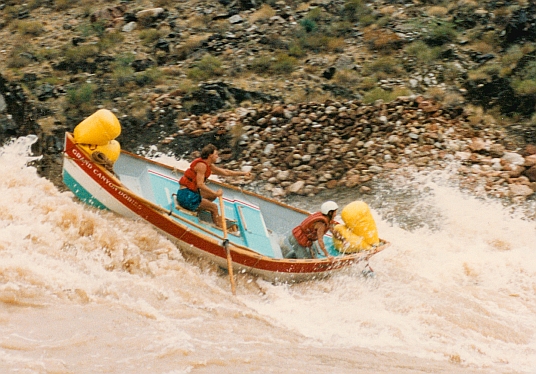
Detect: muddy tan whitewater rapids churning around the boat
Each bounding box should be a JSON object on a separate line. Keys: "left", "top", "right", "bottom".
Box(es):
{"left": 0, "top": 136, "right": 536, "bottom": 374}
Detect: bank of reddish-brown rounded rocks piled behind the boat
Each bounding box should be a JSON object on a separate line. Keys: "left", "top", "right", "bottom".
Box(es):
{"left": 161, "top": 96, "right": 536, "bottom": 200}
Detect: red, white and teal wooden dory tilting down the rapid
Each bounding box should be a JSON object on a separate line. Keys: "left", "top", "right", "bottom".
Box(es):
{"left": 63, "top": 133, "right": 389, "bottom": 282}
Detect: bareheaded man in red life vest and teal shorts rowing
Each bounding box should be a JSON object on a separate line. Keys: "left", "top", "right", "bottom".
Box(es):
{"left": 177, "top": 144, "right": 251, "bottom": 227}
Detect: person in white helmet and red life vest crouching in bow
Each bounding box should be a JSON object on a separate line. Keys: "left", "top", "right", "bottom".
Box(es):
{"left": 285, "top": 201, "right": 339, "bottom": 258}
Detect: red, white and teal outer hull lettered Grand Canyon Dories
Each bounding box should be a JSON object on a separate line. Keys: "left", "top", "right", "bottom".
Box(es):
{"left": 63, "top": 133, "right": 388, "bottom": 282}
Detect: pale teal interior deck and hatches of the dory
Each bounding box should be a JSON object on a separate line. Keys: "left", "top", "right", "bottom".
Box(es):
{"left": 114, "top": 154, "right": 340, "bottom": 258}
